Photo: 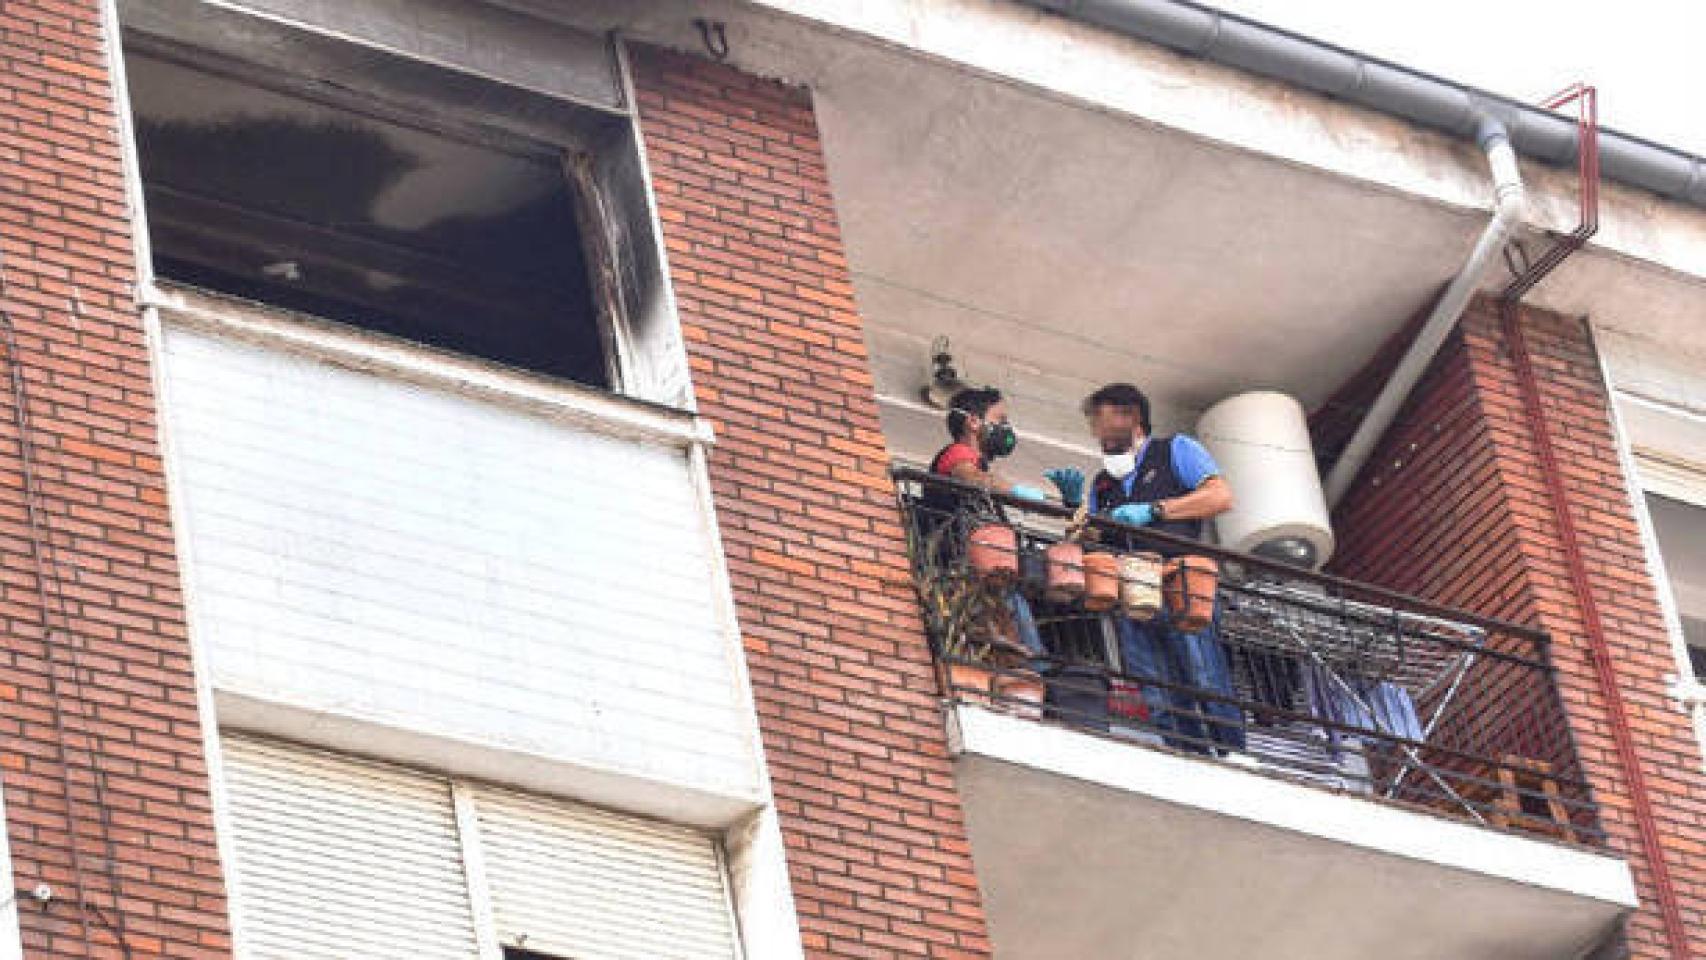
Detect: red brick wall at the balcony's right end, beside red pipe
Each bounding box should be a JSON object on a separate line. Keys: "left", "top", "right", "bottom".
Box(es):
{"left": 1332, "top": 296, "right": 1706, "bottom": 958}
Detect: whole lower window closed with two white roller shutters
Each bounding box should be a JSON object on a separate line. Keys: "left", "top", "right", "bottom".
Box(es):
{"left": 220, "top": 733, "right": 739, "bottom": 960}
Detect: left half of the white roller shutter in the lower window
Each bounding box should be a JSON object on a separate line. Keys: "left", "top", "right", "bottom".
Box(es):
{"left": 223, "top": 735, "right": 478, "bottom": 960}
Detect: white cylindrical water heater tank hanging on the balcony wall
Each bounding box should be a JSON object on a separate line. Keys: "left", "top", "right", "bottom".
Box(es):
{"left": 1196, "top": 390, "right": 1332, "bottom": 570}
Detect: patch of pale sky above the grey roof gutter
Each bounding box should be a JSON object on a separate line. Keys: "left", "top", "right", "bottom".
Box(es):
{"left": 1206, "top": 0, "right": 1706, "bottom": 155}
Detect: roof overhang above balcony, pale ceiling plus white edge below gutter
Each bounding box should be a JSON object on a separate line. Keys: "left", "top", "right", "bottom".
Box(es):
{"left": 515, "top": 0, "right": 1706, "bottom": 454}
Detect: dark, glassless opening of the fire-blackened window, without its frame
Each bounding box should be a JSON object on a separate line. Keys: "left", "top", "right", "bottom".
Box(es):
{"left": 126, "top": 53, "right": 612, "bottom": 387}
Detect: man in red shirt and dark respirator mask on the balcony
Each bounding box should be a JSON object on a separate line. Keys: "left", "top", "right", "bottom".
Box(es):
{"left": 923, "top": 387, "right": 1047, "bottom": 656}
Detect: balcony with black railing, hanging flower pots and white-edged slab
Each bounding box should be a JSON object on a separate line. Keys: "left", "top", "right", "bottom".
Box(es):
{"left": 896, "top": 469, "right": 1633, "bottom": 960}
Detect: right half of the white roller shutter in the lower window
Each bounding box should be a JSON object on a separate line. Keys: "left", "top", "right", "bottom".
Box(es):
{"left": 474, "top": 786, "right": 739, "bottom": 960}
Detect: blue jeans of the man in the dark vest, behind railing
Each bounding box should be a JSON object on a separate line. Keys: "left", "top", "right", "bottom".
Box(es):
{"left": 1114, "top": 604, "right": 1244, "bottom": 754}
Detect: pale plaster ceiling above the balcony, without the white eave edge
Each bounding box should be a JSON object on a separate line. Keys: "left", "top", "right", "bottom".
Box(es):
{"left": 798, "top": 47, "right": 1706, "bottom": 438}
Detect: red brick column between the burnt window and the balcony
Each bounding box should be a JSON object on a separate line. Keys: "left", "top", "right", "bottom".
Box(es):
{"left": 636, "top": 49, "right": 989, "bottom": 957}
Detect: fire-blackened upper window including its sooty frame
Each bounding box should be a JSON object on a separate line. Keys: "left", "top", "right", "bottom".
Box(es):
{"left": 118, "top": 0, "right": 693, "bottom": 408}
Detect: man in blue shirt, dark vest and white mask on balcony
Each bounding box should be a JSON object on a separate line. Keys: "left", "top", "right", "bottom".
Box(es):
{"left": 1047, "top": 384, "right": 1244, "bottom": 752}
